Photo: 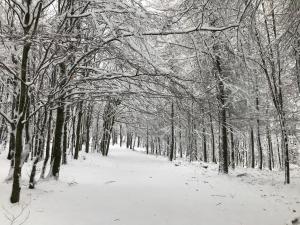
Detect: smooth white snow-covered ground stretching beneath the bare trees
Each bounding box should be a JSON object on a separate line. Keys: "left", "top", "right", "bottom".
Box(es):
{"left": 0, "top": 147, "right": 300, "bottom": 225}
